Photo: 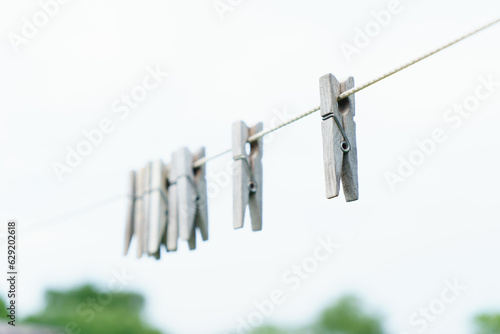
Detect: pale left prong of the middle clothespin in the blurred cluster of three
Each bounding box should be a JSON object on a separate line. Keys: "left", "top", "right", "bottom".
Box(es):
{"left": 148, "top": 160, "right": 168, "bottom": 258}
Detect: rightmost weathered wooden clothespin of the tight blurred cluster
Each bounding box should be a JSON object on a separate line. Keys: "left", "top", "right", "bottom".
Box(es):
{"left": 167, "top": 147, "right": 208, "bottom": 251}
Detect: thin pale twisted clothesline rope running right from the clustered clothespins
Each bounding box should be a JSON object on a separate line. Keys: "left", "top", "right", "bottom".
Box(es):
{"left": 194, "top": 18, "right": 500, "bottom": 168}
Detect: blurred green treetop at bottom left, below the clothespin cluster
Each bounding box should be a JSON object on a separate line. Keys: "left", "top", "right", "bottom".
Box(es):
{"left": 23, "top": 285, "right": 161, "bottom": 334}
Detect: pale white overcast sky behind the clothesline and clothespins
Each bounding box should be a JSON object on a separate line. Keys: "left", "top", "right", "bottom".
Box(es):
{"left": 0, "top": 0, "right": 500, "bottom": 334}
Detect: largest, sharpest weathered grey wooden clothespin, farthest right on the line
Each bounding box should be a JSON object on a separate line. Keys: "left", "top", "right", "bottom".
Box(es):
{"left": 319, "top": 74, "right": 359, "bottom": 202}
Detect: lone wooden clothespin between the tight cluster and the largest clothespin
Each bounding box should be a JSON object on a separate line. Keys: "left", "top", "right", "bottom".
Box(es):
{"left": 232, "top": 121, "right": 263, "bottom": 231}
